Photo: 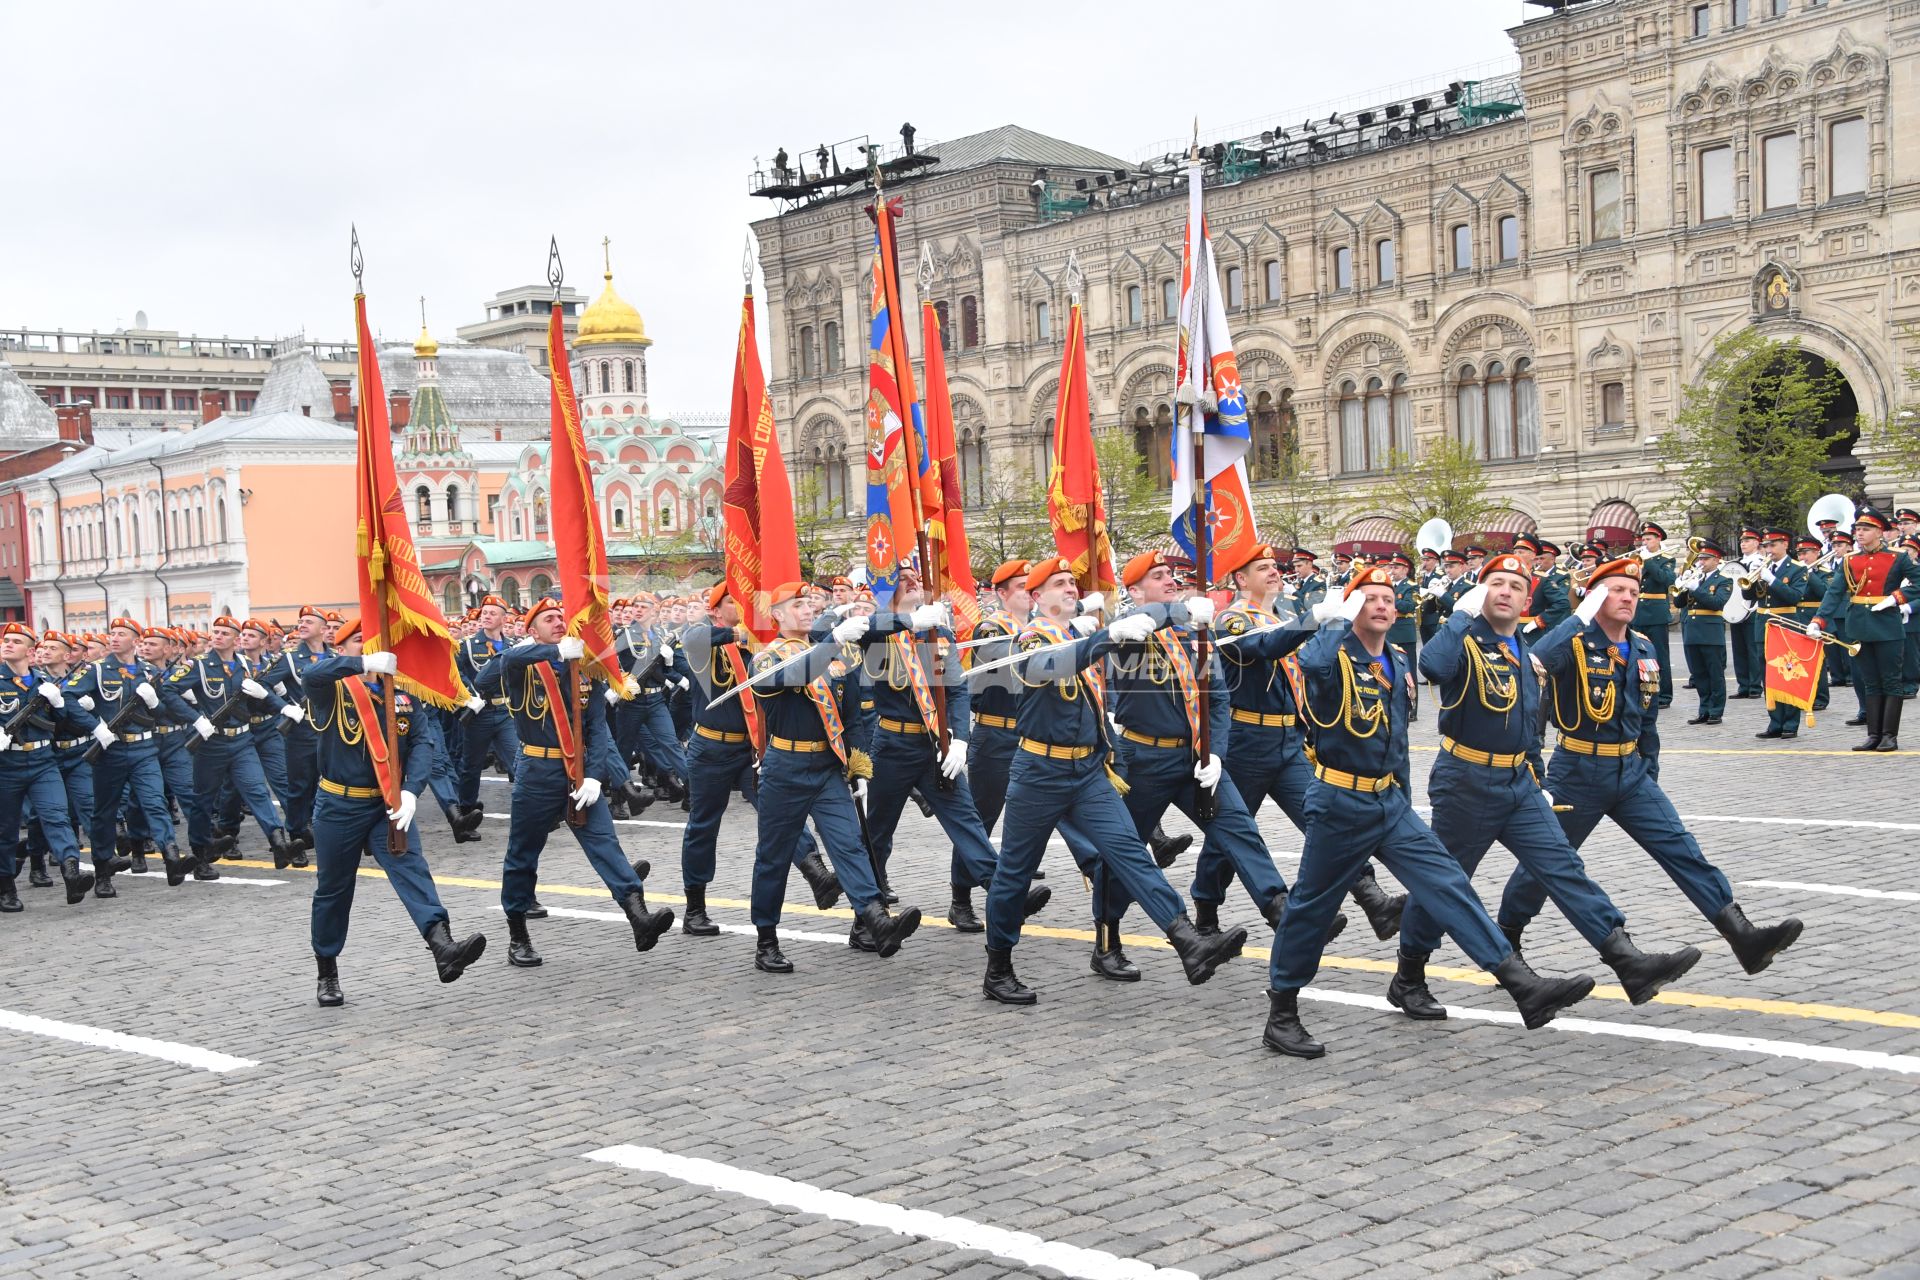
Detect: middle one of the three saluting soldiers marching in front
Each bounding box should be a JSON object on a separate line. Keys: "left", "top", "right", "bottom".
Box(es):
{"left": 1386, "top": 555, "right": 1699, "bottom": 1019}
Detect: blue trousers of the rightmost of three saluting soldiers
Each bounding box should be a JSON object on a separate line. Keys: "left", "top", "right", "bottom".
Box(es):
{"left": 1500, "top": 750, "right": 1734, "bottom": 927}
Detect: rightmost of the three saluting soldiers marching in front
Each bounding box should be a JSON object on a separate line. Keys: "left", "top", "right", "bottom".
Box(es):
{"left": 1500, "top": 560, "right": 1801, "bottom": 973}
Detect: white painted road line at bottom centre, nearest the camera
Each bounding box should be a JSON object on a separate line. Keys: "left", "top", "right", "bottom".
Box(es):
{"left": 588, "top": 1146, "right": 1198, "bottom": 1280}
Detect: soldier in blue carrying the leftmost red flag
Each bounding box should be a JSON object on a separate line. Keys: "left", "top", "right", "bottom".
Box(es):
{"left": 300, "top": 622, "right": 486, "bottom": 1007}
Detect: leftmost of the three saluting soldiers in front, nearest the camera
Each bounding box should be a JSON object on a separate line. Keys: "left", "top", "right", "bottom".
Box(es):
{"left": 1261, "top": 564, "right": 1594, "bottom": 1057}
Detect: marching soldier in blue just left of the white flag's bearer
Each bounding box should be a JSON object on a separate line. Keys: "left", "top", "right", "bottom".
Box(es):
{"left": 981, "top": 557, "right": 1246, "bottom": 1004}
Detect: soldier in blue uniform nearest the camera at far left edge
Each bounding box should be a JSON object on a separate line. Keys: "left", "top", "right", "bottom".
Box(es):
{"left": 0, "top": 622, "right": 113, "bottom": 912}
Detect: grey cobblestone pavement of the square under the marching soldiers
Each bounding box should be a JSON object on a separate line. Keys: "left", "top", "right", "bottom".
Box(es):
{"left": 0, "top": 717, "right": 1920, "bottom": 1280}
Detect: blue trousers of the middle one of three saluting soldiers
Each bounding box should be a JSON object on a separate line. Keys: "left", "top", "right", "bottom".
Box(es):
{"left": 1400, "top": 752, "right": 1626, "bottom": 952}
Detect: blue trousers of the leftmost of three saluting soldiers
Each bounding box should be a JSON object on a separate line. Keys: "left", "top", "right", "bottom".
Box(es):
{"left": 1267, "top": 781, "right": 1513, "bottom": 990}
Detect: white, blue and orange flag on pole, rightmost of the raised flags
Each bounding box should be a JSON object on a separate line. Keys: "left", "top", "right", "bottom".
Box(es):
{"left": 1169, "top": 157, "right": 1260, "bottom": 583}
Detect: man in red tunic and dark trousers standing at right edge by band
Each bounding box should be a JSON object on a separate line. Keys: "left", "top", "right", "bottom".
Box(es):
{"left": 1812, "top": 507, "right": 1920, "bottom": 750}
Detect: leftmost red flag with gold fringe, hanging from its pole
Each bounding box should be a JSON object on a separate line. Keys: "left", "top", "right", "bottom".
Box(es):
{"left": 353, "top": 294, "right": 472, "bottom": 710}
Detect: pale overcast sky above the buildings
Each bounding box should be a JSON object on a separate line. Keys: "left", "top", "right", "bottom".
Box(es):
{"left": 0, "top": 0, "right": 1540, "bottom": 415}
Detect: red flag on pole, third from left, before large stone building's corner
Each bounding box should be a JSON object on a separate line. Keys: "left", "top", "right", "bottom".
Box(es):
{"left": 722, "top": 288, "right": 801, "bottom": 640}
